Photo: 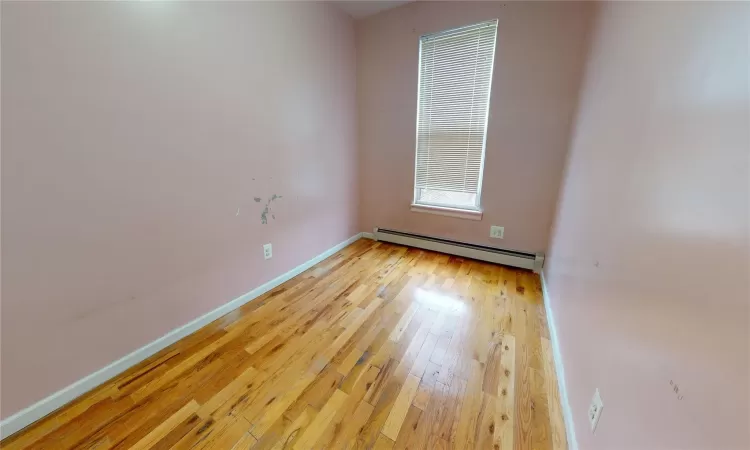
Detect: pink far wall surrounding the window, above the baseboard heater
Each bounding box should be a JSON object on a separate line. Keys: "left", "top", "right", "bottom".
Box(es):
{"left": 356, "top": 2, "right": 592, "bottom": 251}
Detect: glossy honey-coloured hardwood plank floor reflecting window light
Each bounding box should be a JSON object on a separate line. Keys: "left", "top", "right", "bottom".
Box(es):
{"left": 0, "top": 240, "right": 566, "bottom": 450}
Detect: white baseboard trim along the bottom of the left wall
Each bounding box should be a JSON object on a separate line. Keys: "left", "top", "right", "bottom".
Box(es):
{"left": 0, "top": 233, "right": 363, "bottom": 439}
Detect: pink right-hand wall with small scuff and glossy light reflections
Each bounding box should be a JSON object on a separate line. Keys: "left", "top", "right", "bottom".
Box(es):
{"left": 546, "top": 2, "right": 750, "bottom": 450}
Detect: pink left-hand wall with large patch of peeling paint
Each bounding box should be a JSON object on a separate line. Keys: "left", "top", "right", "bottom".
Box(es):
{"left": 1, "top": 2, "right": 359, "bottom": 417}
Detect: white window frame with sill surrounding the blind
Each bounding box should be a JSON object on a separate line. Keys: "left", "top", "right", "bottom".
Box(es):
{"left": 411, "top": 19, "right": 498, "bottom": 216}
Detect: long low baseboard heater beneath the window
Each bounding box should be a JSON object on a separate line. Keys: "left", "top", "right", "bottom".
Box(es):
{"left": 374, "top": 228, "right": 544, "bottom": 273}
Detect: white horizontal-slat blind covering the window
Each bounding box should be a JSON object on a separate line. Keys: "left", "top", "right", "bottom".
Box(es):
{"left": 414, "top": 20, "right": 497, "bottom": 210}
